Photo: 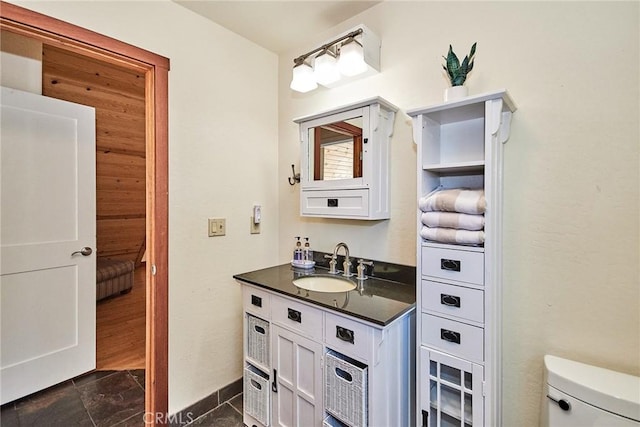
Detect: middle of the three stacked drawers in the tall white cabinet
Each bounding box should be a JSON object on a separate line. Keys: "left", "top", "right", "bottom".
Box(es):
{"left": 422, "top": 280, "right": 484, "bottom": 323}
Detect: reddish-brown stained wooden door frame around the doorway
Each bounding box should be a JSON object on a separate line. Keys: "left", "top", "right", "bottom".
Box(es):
{"left": 0, "top": 1, "right": 169, "bottom": 425}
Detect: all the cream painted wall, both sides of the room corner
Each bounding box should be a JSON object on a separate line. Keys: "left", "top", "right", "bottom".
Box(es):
{"left": 6, "top": 1, "right": 640, "bottom": 426}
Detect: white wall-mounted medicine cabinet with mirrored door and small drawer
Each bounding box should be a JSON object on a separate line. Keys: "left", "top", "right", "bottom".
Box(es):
{"left": 294, "top": 97, "right": 398, "bottom": 220}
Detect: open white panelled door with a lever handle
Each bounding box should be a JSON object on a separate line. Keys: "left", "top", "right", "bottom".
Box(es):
{"left": 0, "top": 87, "right": 96, "bottom": 404}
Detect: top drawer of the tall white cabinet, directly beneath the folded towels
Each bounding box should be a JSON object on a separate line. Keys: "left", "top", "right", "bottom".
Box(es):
{"left": 422, "top": 246, "right": 484, "bottom": 285}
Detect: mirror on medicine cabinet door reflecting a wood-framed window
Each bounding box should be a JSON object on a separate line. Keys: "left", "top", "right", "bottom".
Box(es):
{"left": 309, "top": 117, "right": 362, "bottom": 181}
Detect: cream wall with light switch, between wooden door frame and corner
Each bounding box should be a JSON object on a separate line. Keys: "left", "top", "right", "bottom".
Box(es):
{"left": 6, "top": 1, "right": 278, "bottom": 413}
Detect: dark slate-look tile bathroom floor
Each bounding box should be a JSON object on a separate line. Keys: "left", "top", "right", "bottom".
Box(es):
{"left": 0, "top": 370, "right": 242, "bottom": 427}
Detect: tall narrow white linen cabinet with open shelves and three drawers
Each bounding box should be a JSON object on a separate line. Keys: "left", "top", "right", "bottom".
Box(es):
{"left": 407, "top": 91, "right": 515, "bottom": 427}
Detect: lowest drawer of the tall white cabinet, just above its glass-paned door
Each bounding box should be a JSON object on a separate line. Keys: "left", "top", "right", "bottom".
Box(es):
{"left": 421, "top": 313, "right": 484, "bottom": 363}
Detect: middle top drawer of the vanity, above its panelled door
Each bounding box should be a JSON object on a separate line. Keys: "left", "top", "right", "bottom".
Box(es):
{"left": 271, "top": 295, "right": 322, "bottom": 340}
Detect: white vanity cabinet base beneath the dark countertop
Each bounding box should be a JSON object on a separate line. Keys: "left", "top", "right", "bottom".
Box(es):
{"left": 242, "top": 283, "right": 415, "bottom": 427}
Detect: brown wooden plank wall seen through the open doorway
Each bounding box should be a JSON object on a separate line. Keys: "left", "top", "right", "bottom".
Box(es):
{"left": 42, "top": 45, "right": 146, "bottom": 265}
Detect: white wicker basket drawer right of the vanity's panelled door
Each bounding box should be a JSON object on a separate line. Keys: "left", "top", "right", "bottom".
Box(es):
{"left": 324, "top": 351, "right": 369, "bottom": 427}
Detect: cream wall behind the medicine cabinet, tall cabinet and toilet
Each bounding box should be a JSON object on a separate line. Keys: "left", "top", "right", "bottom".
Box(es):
{"left": 278, "top": 1, "right": 640, "bottom": 426}
